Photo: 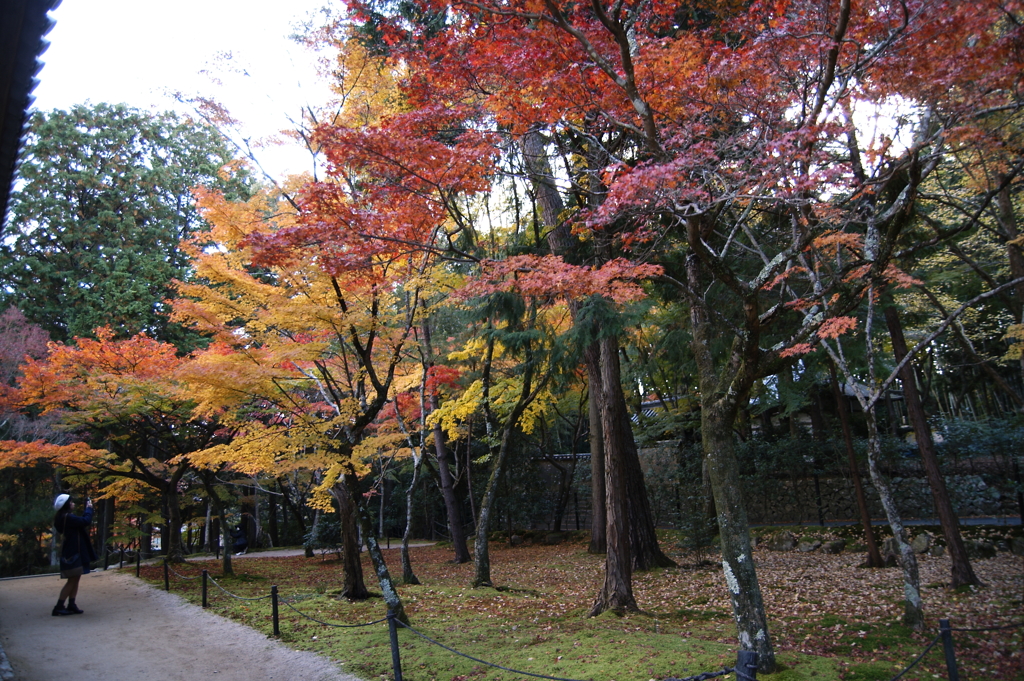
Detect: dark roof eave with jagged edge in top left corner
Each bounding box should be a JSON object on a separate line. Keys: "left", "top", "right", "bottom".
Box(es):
{"left": 0, "top": 0, "right": 60, "bottom": 223}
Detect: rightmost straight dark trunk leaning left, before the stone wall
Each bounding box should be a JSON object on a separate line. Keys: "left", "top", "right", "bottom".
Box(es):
{"left": 885, "top": 305, "right": 981, "bottom": 589}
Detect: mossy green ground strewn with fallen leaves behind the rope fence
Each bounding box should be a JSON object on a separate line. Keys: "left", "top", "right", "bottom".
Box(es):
{"left": 132, "top": 539, "right": 1024, "bottom": 681}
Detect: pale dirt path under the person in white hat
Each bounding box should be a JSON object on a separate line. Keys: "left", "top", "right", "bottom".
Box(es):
{"left": 0, "top": 569, "right": 358, "bottom": 681}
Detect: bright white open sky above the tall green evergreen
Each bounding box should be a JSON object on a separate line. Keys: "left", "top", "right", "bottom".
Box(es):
{"left": 33, "top": 0, "right": 338, "bottom": 178}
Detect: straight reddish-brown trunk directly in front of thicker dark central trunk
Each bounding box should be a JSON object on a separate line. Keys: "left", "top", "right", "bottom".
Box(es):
{"left": 590, "top": 336, "right": 638, "bottom": 616}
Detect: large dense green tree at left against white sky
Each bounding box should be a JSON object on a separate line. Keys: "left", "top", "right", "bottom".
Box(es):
{"left": 0, "top": 104, "right": 248, "bottom": 348}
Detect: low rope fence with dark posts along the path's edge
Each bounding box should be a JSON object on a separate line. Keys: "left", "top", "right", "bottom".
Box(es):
{"left": 140, "top": 551, "right": 1024, "bottom": 681}
